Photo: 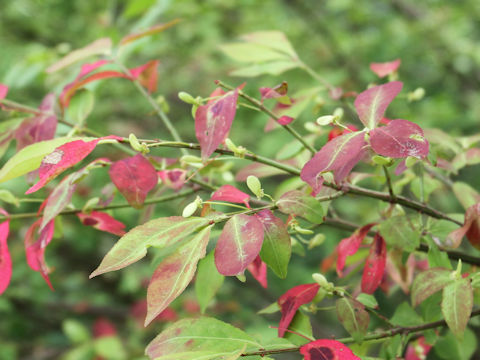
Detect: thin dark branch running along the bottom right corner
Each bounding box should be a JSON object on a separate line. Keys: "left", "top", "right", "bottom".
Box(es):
{"left": 244, "top": 309, "right": 480, "bottom": 357}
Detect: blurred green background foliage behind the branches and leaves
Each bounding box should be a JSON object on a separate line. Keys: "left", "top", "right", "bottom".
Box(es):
{"left": 0, "top": 0, "right": 480, "bottom": 360}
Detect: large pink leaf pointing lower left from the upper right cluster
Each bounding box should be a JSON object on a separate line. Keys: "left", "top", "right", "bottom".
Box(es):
{"left": 300, "top": 131, "right": 366, "bottom": 194}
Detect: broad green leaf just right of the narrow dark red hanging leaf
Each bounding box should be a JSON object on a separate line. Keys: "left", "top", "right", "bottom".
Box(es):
{"left": 378, "top": 215, "right": 420, "bottom": 252}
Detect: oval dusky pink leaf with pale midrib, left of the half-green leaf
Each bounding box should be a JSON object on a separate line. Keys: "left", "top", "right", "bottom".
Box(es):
{"left": 215, "top": 214, "right": 263, "bottom": 276}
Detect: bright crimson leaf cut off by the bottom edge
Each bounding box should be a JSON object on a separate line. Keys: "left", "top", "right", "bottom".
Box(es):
{"left": 300, "top": 339, "right": 360, "bottom": 360}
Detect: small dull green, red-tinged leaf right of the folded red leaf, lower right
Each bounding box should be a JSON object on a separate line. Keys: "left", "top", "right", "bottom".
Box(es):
{"left": 336, "top": 297, "right": 370, "bottom": 342}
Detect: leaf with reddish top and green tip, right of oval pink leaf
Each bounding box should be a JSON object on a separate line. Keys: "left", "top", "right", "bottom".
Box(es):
{"left": 256, "top": 209, "right": 292, "bottom": 279}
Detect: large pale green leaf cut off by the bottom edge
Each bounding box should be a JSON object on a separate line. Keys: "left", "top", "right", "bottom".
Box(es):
{"left": 145, "top": 317, "right": 262, "bottom": 360}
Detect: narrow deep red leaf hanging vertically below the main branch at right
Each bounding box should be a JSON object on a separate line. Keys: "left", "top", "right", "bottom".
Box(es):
{"left": 362, "top": 233, "right": 387, "bottom": 294}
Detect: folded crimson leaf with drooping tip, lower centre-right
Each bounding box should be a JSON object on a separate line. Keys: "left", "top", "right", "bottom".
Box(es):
{"left": 278, "top": 283, "right": 320, "bottom": 337}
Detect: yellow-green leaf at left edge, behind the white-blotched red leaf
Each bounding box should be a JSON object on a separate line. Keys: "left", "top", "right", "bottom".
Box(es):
{"left": 0, "top": 136, "right": 84, "bottom": 183}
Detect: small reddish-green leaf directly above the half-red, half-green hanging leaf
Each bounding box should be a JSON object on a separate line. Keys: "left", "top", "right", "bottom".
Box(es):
{"left": 277, "top": 190, "right": 324, "bottom": 224}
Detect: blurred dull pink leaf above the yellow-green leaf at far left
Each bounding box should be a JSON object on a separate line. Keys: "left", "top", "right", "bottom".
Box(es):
{"left": 15, "top": 94, "right": 57, "bottom": 151}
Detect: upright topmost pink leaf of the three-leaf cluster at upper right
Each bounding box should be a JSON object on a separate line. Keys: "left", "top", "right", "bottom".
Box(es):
{"left": 354, "top": 81, "right": 403, "bottom": 129}
